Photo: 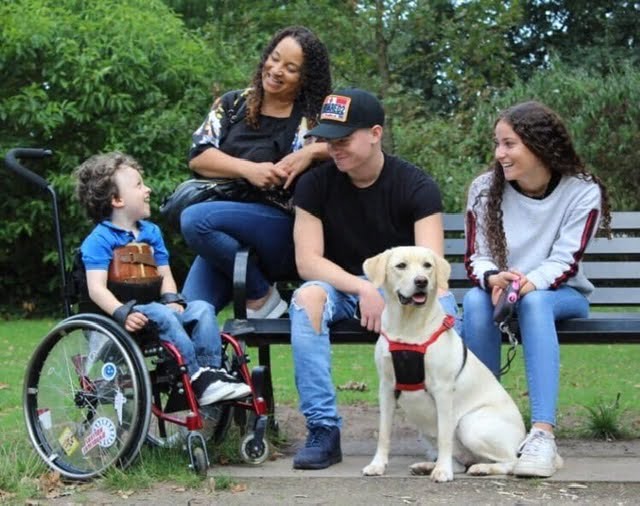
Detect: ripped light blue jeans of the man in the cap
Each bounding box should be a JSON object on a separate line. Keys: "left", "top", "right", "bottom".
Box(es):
{"left": 289, "top": 281, "right": 457, "bottom": 428}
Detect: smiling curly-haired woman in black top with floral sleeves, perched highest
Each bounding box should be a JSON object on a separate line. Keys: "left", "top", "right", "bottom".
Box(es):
{"left": 181, "top": 26, "right": 331, "bottom": 318}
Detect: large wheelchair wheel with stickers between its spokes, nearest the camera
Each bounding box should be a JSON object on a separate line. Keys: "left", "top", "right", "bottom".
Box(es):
{"left": 23, "top": 314, "right": 151, "bottom": 479}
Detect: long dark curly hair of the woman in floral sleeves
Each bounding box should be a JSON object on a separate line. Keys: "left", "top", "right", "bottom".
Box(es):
{"left": 246, "top": 26, "right": 332, "bottom": 128}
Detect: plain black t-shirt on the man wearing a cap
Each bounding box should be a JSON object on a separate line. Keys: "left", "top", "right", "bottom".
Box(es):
{"left": 293, "top": 154, "right": 442, "bottom": 276}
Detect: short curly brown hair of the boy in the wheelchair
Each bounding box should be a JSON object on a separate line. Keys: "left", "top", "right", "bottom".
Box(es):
{"left": 73, "top": 151, "right": 143, "bottom": 223}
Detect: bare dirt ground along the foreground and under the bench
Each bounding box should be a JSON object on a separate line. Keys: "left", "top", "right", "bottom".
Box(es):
{"left": 40, "top": 406, "right": 640, "bottom": 506}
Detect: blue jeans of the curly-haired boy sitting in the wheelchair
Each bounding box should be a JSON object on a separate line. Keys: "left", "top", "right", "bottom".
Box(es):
{"left": 133, "top": 300, "right": 222, "bottom": 376}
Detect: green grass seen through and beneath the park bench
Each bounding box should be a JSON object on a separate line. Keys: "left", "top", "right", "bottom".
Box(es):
{"left": 255, "top": 344, "right": 640, "bottom": 437}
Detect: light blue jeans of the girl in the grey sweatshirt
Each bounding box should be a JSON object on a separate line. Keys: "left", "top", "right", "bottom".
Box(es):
{"left": 462, "top": 285, "right": 589, "bottom": 425}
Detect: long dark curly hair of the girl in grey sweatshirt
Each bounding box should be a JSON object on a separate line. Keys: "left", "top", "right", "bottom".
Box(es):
{"left": 473, "top": 101, "right": 611, "bottom": 270}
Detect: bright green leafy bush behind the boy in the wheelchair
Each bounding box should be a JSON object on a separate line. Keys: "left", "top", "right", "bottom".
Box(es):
{"left": 0, "top": 0, "right": 227, "bottom": 312}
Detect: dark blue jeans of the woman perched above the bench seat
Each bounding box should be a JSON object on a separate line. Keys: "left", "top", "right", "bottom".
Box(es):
{"left": 180, "top": 201, "right": 297, "bottom": 310}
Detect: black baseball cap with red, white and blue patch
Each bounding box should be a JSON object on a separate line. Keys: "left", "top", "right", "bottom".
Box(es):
{"left": 305, "top": 88, "right": 384, "bottom": 139}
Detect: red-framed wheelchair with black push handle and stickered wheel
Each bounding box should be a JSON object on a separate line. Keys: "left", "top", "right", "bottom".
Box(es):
{"left": 4, "top": 148, "right": 272, "bottom": 480}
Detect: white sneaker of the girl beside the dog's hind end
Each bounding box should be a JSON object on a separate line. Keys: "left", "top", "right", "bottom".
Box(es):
{"left": 513, "top": 427, "right": 562, "bottom": 478}
